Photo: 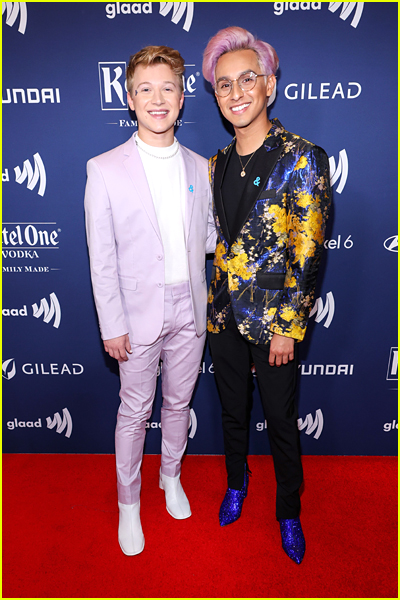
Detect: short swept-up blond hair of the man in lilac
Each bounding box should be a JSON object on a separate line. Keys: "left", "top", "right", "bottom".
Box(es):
{"left": 126, "top": 46, "right": 185, "bottom": 94}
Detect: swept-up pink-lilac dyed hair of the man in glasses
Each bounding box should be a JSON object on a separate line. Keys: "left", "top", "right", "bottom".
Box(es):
{"left": 203, "top": 27, "right": 279, "bottom": 86}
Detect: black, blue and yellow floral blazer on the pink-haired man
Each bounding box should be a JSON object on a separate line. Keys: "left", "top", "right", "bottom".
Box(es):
{"left": 207, "top": 119, "right": 331, "bottom": 344}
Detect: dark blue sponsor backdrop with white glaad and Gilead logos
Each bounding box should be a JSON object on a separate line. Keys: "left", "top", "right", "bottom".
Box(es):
{"left": 2, "top": 2, "right": 398, "bottom": 455}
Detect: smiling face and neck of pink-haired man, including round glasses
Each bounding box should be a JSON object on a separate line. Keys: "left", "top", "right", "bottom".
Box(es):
{"left": 214, "top": 49, "right": 276, "bottom": 151}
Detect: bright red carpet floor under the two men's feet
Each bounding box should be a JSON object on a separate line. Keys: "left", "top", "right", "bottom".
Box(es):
{"left": 3, "top": 454, "right": 397, "bottom": 598}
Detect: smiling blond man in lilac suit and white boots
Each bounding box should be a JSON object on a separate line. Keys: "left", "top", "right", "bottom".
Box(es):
{"left": 85, "top": 46, "right": 215, "bottom": 556}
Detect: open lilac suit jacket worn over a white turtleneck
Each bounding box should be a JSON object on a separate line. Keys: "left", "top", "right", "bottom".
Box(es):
{"left": 85, "top": 137, "right": 216, "bottom": 345}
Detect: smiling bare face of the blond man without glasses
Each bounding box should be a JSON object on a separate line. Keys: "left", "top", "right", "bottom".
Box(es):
{"left": 128, "top": 64, "right": 183, "bottom": 147}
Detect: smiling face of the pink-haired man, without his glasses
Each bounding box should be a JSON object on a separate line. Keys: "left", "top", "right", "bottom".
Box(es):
{"left": 215, "top": 50, "right": 275, "bottom": 135}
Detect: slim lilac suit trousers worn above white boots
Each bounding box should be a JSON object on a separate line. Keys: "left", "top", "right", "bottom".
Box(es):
{"left": 115, "top": 282, "right": 205, "bottom": 504}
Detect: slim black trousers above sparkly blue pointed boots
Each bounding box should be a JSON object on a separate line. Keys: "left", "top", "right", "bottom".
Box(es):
{"left": 209, "top": 315, "right": 303, "bottom": 520}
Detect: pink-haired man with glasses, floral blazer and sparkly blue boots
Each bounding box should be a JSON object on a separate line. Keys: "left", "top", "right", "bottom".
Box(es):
{"left": 203, "top": 27, "right": 331, "bottom": 564}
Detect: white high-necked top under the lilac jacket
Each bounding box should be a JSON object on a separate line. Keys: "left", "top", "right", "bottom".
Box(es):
{"left": 134, "top": 132, "right": 189, "bottom": 285}
